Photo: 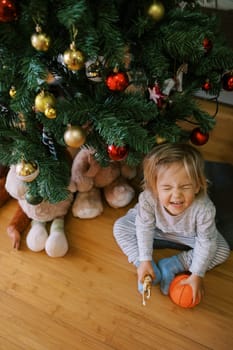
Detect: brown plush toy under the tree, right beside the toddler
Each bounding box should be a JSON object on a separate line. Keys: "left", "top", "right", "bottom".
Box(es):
{"left": 70, "top": 147, "right": 137, "bottom": 219}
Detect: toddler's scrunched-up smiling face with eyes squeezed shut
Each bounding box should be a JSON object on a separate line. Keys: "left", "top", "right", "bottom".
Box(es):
{"left": 157, "top": 163, "right": 200, "bottom": 215}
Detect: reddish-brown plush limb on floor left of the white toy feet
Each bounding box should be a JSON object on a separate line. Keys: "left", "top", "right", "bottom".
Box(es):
{"left": 7, "top": 204, "right": 30, "bottom": 249}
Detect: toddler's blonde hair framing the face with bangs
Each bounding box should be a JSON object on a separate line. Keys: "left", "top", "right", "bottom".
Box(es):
{"left": 143, "top": 143, "right": 207, "bottom": 195}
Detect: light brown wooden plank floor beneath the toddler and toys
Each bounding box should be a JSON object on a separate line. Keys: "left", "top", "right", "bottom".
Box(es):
{"left": 0, "top": 99, "right": 233, "bottom": 350}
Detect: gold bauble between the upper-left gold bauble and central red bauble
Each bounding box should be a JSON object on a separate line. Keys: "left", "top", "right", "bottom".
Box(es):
{"left": 63, "top": 42, "right": 85, "bottom": 71}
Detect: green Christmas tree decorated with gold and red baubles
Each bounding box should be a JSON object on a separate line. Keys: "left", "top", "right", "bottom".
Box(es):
{"left": 0, "top": 0, "right": 233, "bottom": 204}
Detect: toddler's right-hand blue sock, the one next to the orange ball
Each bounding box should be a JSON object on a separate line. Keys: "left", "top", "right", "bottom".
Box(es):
{"left": 158, "top": 255, "right": 185, "bottom": 295}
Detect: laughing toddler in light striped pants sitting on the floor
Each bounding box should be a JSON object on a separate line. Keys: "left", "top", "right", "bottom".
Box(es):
{"left": 113, "top": 143, "right": 230, "bottom": 302}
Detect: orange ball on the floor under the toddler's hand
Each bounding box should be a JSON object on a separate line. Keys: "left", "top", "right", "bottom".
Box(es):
{"left": 169, "top": 274, "right": 201, "bottom": 308}
